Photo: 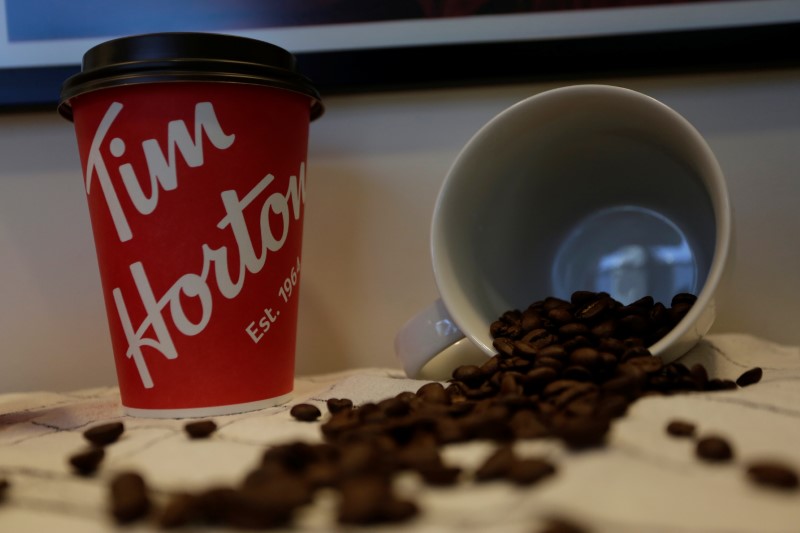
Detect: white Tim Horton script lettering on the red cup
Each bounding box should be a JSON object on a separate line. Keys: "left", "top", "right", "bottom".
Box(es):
{"left": 85, "top": 102, "right": 305, "bottom": 388}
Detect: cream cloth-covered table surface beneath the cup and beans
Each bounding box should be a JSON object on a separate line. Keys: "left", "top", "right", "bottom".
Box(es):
{"left": 0, "top": 334, "right": 800, "bottom": 533}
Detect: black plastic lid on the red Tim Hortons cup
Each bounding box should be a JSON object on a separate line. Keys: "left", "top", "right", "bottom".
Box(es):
{"left": 58, "top": 32, "right": 323, "bottom": 120}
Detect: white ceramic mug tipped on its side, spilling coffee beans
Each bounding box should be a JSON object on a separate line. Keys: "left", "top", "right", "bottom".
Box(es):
{"left": 395, "top": 85, "right": 731, "bottom": 379}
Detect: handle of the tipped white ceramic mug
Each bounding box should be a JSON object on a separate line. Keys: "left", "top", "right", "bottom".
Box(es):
{"left": 394, "top": 298, "right": 489, "bottom": 381}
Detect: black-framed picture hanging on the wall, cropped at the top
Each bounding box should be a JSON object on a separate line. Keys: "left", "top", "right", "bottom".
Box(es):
{"left": 0, "top": 0, "right": 800, "bottom": 109}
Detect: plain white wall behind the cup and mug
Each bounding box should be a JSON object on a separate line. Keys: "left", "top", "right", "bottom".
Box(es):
{"left": 0, "top": 66, "right": 800, "bottom": 392}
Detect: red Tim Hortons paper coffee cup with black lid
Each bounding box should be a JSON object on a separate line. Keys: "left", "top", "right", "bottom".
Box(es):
{"left": 59, "top": 33, "right": 322, "bottom": 417}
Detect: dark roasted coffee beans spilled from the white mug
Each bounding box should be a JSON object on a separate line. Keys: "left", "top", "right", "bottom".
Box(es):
{"left": 51, "top": 291, "right": 797, "bottom": 532}
